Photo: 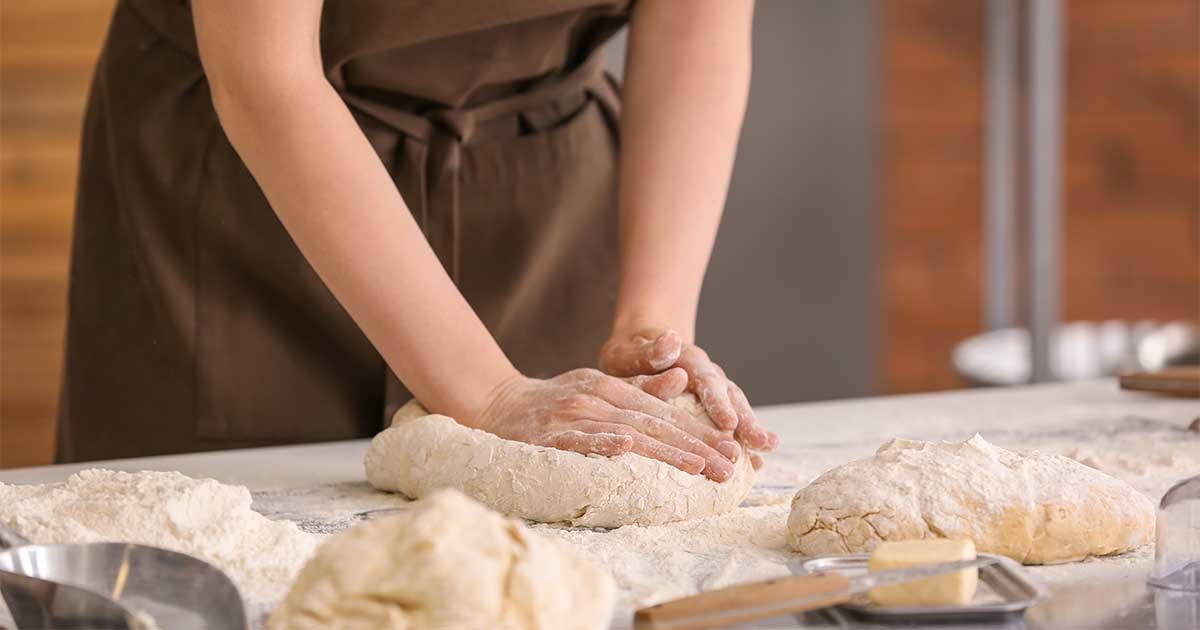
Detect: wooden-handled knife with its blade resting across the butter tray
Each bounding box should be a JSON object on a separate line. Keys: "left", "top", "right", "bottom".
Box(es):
{"left": 634, "top": 558, "right": 996, "bottom": 630}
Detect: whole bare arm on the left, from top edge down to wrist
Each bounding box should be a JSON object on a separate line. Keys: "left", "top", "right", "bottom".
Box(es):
{"left": 193, "top": 0, "right": 517, "bottom": 418}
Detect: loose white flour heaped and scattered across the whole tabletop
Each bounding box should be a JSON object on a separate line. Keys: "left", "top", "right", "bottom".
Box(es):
{"left": 0, "top": 412, "right": 1200, "bottom": 628}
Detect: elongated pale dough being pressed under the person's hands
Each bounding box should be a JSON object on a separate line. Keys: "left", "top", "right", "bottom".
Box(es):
{"left": 365, "top": 395, "right": 755, "bottom": 527}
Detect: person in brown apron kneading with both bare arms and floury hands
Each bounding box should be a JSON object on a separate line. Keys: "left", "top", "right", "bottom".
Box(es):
{"left": 59, "top": 0, "right": 778, "bottom": 481}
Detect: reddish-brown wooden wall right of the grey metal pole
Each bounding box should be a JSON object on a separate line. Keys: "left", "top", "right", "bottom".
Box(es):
{"left": 1063, "top": 0, "right": 1200, "bottom": 319}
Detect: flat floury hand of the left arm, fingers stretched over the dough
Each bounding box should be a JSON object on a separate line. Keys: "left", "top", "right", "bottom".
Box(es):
{"left": 463, "top": 368, "right": 742, "bottom": 482}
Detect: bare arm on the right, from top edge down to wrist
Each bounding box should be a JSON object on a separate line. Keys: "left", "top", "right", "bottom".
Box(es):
{"left": 616, "top": 0, "right": 752, "bottom": 341}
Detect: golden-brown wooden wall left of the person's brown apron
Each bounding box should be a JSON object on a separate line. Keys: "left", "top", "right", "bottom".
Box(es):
{"left": 0, "top": 0, "right": 113, "bottom": 467}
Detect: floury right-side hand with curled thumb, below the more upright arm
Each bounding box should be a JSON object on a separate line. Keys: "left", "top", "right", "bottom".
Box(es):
{"left": 600, "top": 329, "right": 779, "bottom": 460}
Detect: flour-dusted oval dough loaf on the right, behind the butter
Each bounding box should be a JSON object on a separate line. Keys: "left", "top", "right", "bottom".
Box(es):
{"left": 787, "top": 436, "right": 1154, "bottom": 564}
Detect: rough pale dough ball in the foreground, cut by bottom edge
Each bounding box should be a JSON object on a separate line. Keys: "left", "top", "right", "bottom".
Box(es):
{"left": 268, "top": 490, "right": 616, "bottom": 630}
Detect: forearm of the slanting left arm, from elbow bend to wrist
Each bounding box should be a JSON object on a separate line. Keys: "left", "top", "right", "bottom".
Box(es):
{"left": 214, "top": 76, "right": 516, "bottom": 418}
